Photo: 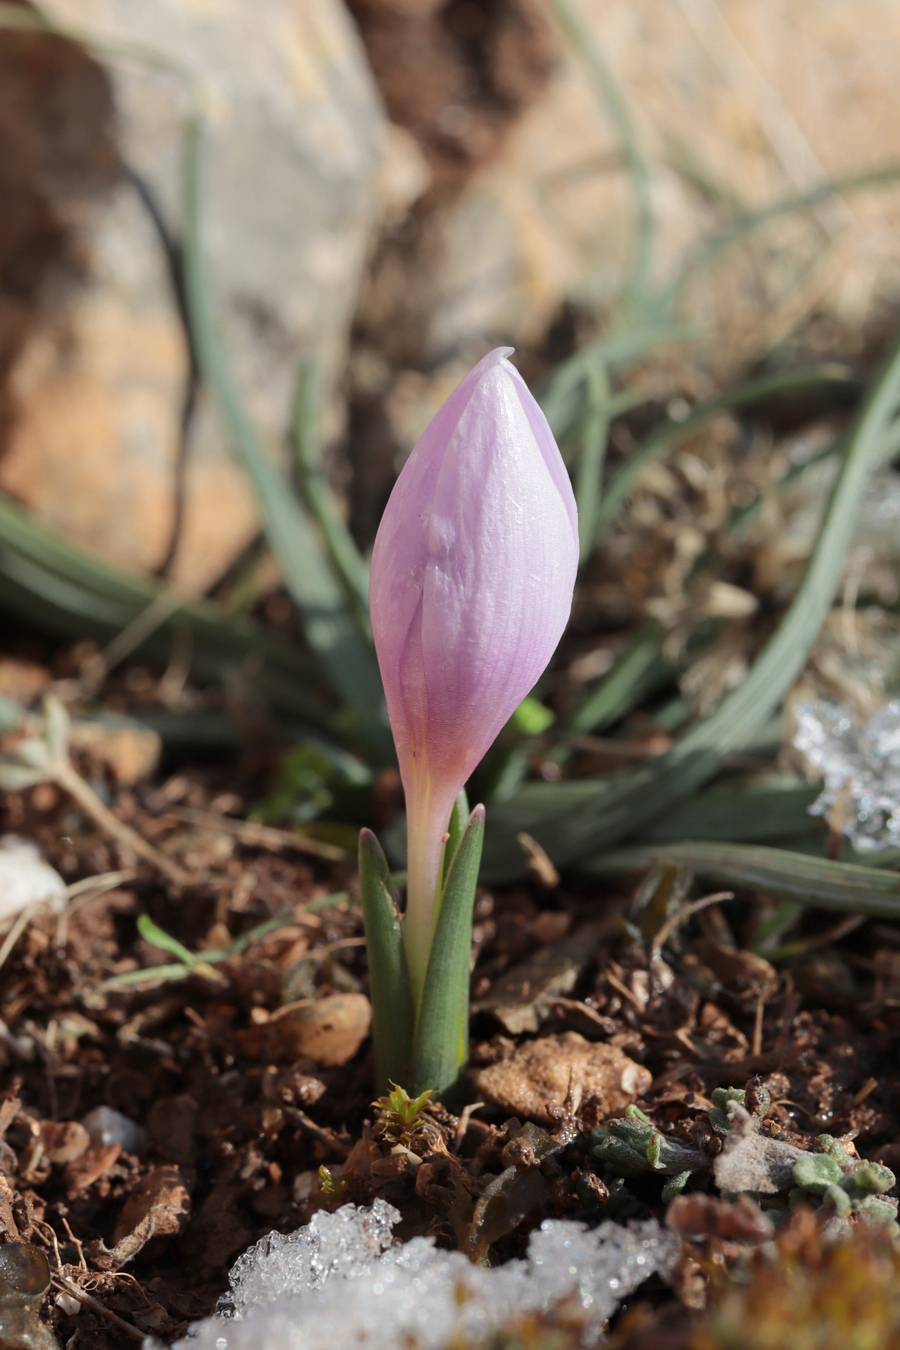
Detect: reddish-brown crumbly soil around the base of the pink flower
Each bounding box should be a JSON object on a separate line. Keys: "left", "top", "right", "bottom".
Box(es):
{"left": 0, "top": 656, "right": 900, "bottom": 1350}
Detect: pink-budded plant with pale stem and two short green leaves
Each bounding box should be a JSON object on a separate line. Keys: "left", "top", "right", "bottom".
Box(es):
{"left": 359, "top": 347, "right": 578, "bottom": 1094}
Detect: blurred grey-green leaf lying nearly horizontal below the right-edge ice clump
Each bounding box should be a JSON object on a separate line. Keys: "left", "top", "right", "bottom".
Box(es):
{"left": 583, "top": 841, "right": 900, "bottom": 919}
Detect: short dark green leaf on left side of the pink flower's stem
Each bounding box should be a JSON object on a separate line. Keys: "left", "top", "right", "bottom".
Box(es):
{"left": 359, "top": 830, "right": 414, "bottom": 1092}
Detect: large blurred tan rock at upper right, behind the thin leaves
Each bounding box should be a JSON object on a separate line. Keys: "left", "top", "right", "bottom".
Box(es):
{"left": 352, "top": 0, "right": 900, "bottom": 380}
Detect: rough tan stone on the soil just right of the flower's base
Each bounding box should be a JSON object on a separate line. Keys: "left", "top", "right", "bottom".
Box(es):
{"left": 474, "top": 1031, "right": 652, "bottom": 1125}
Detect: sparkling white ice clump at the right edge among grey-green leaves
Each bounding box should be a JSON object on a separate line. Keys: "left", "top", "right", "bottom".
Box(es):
{"left": 793, "top": 699, "right": 900, "bottom": 851}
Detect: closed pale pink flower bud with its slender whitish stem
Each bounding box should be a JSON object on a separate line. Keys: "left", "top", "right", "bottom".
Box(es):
{"left": 370, "top": 347, "right": 579, "bottom": 1006}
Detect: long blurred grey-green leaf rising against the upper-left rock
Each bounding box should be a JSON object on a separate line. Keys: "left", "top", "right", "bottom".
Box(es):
{"left": 184, "top": 116, "right": 393, "bottom": 763}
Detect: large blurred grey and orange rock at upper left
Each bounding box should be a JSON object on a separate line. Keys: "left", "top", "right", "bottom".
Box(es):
{"left": 0, "top": 0, "right": 385, "bottom": 590}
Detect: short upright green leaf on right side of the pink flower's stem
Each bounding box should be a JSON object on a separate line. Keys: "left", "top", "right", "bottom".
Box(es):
{"left": 413, "top": 806, "right": 484, "bottom": 1098}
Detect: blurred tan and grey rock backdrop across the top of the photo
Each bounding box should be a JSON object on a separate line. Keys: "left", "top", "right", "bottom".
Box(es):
{"left": 0, "top": 0, "right": 900, "bottom": 591}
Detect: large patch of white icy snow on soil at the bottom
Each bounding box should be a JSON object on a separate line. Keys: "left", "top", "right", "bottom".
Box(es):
{"left": 179, "top": 1200, "right": 677, "bottom": 1350}
